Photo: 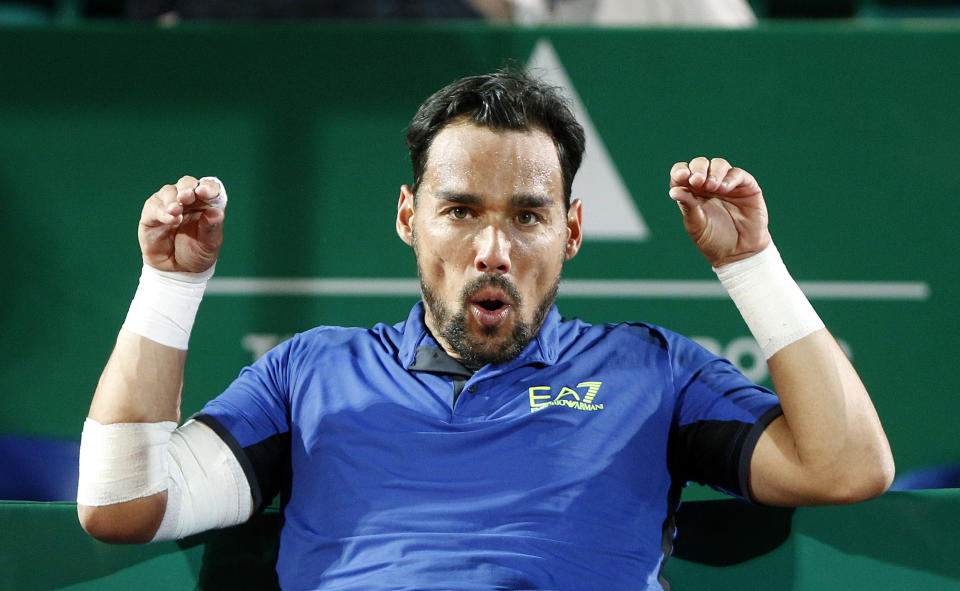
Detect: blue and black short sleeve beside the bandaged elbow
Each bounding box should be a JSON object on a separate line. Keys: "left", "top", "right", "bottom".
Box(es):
{"left": 193, "top": 337, "right": 297, "bottom": 511}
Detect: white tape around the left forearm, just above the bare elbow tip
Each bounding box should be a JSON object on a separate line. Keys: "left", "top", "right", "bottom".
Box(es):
{"left": 77, "top": 418, "right": 177, "bottom": 507}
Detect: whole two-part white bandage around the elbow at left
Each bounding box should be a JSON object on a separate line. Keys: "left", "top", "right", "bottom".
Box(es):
{"left": 77, "top": 419, "right": 253, "bottom": 541}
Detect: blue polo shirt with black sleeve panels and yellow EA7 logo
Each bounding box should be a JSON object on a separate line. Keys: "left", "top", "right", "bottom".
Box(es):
{"left": 198, "top": 303, "right": 779, "bottom": 590}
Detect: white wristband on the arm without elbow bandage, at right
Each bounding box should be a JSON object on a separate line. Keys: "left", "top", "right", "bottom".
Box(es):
{"left": 713, "top": 242, "right": 823, "bottom": 359}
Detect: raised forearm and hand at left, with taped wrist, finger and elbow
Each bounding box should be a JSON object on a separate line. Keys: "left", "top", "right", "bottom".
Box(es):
{"left": 77, "top": 176, "right": 226, "bottom": 542}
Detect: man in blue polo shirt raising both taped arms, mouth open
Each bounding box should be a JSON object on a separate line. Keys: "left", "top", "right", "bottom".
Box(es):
{"left": 78, "top": 73, "right": 893, "bottom": 589}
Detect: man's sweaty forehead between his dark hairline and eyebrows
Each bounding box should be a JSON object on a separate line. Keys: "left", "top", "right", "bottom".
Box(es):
{"left": 423, "top": 120, "right": 562, "bottom": 199}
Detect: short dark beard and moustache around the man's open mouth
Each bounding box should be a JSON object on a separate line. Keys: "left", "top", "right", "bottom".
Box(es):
{"left": 417, "top": 272, "right": 560, "bottom": 370}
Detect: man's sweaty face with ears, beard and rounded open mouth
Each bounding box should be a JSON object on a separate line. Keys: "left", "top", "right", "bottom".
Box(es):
{"left": 397, "top": 120, "right": 580, "bottom": 366}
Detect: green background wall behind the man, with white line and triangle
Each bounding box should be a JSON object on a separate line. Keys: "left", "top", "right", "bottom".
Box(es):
{"left": 0, "top": 25, "right": 960, "bottom": 488}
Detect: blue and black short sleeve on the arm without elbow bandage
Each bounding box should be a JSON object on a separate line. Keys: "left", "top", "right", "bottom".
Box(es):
{"left": 668, "top": 341, "right": 782, "bottom": 499}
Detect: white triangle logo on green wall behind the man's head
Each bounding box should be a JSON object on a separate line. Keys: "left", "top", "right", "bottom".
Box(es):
{"left": 527, "top": 39, "right": 650, "bottom": 241}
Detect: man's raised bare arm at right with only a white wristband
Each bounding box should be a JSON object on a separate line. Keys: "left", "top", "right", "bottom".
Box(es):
{"left": 670, "top": 157, "right": 894, "bottom": 505}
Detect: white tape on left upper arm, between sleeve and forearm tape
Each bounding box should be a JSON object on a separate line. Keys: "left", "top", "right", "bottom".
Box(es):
{"left": 152, "top": 419, "right": 253, "bottom": 542}
